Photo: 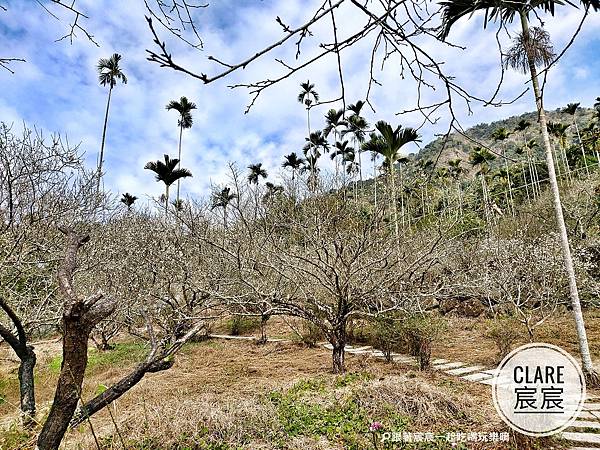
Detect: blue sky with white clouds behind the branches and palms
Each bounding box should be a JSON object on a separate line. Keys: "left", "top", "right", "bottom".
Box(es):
{"left": 0, "top": 0, "right": 600, "bottom": 205}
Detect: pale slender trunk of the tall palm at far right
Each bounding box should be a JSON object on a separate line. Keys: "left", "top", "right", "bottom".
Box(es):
{"left": 520, "top": 12, "right": 599, "bottom": 384}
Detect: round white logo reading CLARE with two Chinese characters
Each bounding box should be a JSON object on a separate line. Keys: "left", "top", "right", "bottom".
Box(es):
{"left": 492, "top": 343, "right": 585, "bottom": 436}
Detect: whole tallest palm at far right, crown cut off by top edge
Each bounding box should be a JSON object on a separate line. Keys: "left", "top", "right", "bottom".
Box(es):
{"left": 440, "top": 0, "right": 600, "bottom": 383}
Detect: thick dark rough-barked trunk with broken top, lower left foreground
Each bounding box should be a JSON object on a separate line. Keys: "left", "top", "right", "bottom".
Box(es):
{"left": 37, "top": 308, "right": 92, "bottom": 450}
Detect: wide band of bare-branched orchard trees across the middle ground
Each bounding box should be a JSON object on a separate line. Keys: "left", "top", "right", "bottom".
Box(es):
{"left": 0, "top": 115, "right": 597, "bottom": 449}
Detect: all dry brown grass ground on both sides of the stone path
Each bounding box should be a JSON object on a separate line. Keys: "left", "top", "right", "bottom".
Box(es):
{"left": 0, "top": 315, "right": 600, "bottom": 450}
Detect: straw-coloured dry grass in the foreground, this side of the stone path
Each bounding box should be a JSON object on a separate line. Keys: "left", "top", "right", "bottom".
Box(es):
{"left": 3, "top": 340, "right": 516, "bottom": 450}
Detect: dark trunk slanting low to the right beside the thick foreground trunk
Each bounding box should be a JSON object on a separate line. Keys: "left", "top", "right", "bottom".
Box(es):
{"left": 70, "top": 359, "right": 173, "bottom": 428}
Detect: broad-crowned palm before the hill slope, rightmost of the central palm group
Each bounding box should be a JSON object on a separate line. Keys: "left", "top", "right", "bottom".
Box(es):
{"left": 363, "top": 120, "right": 420, "bottom": 241}
